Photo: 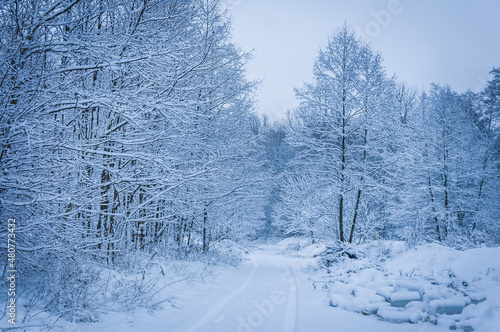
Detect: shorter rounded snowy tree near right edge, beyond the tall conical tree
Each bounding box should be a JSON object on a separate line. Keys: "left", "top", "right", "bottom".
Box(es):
{"left": 391, "top": 85, "right": 498, "bottom": 244}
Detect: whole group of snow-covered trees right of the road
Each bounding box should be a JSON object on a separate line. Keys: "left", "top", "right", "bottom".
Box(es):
{"left": 262, "top": 26, "right": 500, "bottom": 246}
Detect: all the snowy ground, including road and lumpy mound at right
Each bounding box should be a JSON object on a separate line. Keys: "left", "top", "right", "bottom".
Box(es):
{"left": 2, "top": 239, "right": 500, "bottom": 332}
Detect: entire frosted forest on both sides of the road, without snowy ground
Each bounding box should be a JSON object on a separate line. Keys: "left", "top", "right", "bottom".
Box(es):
{"left": 0, "top": 0, "right": 500, "bottom": 328}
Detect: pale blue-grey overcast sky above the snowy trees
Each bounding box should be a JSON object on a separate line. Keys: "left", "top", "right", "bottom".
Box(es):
{"left": 230, "top": 0, "right": 500, "bottom": 118}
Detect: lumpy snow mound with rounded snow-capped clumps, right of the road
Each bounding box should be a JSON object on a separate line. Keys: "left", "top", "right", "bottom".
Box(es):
{"left": 319, "top": 244, "right": 500, "bottom": 331}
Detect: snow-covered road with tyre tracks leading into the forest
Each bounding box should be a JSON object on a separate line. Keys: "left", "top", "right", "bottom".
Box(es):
{"left": 162, "top": 246, "right": 448, "bottom": 332}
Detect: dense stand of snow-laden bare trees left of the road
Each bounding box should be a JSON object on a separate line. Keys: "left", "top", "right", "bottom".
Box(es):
{"left": 0, "top": 0, "right": 261, "bottom": 310}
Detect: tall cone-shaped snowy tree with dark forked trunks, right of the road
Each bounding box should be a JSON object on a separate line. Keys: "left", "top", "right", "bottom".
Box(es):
{"left": 280, "top": 26, "right": 397, "bottom": 242}
